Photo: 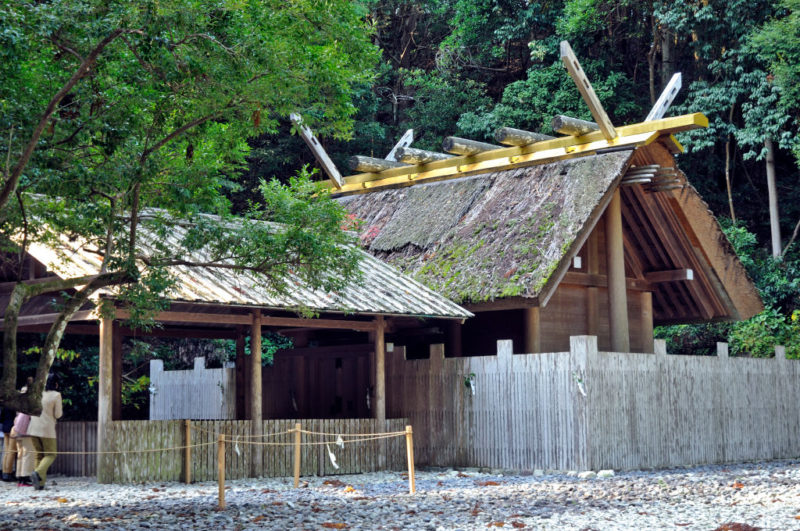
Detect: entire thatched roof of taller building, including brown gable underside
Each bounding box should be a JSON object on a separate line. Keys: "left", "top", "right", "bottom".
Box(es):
{"left": 339, "top": 137, "right": 762, "bottom": 324}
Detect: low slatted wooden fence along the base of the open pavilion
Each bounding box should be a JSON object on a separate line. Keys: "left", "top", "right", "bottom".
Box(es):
{"left": 51, "top": 419, "right": 408, "bottom": 483}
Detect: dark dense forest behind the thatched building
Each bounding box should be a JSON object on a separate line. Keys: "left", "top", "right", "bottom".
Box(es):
{"left": 4, "top": 0, "right": 800, "bottom": 418}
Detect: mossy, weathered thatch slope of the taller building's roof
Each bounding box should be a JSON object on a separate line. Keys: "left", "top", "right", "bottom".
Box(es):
{"left": 339, "top": 151, "right": 631, "bottom": 302}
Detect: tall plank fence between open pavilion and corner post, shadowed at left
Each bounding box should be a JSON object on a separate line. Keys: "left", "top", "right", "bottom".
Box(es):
{"left": 386, "top": 341, "right": 586, "bottom": 469}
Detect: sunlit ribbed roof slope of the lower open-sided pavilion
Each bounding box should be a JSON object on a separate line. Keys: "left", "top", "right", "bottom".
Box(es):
{"left": 29, "top": 216, "right": 472, "bottom": 318}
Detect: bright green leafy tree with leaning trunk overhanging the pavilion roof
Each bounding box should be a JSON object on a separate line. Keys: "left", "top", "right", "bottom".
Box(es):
{"left": 0, "top": 0, "right": 376, "bottom": 413}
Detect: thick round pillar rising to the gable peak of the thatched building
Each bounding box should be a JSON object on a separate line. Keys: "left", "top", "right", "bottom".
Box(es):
{"left": 603, "top": 188, "right": 630, "bottom": 352}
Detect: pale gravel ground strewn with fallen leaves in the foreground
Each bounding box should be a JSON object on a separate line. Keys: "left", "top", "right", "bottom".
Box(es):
{"left": 0, "top": 461, "right": 800, "bottom": 531}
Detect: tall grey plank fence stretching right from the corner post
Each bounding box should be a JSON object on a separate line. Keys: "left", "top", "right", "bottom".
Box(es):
{"left": 586, "top": 342, "right": 800, "bottom": 469}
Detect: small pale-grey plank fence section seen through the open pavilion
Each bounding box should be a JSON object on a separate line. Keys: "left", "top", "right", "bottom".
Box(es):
{"left": 150, "top": 358, "right": 236, "bottom": 420}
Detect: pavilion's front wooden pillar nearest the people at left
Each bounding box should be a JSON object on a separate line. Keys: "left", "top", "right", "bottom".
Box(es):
{"left": 97, "top": 318, "right": 114, "bottom": 483}
